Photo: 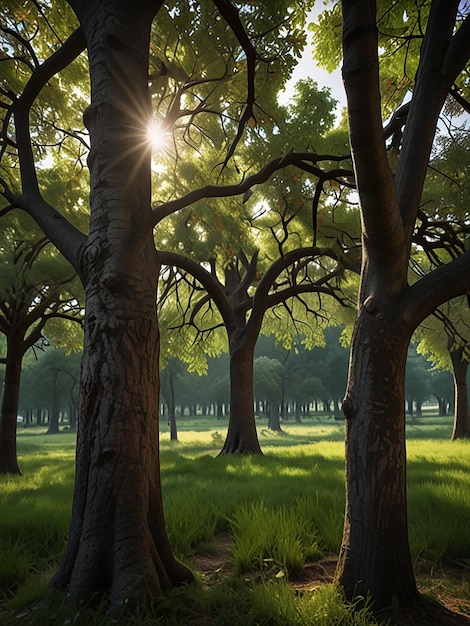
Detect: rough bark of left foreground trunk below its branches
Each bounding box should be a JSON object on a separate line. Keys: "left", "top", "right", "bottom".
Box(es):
{"left": 49, "top": 251, "right": 191, "bottom": 607}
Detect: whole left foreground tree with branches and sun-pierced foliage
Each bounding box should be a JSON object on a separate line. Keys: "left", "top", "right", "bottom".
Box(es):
{"left": 0, "top": 0, "right": 322, "bottom": 613}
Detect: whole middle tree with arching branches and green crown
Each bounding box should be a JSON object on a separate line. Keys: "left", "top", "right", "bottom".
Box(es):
{"left": 155, "top": 80, "right": 358, "bottom": 454}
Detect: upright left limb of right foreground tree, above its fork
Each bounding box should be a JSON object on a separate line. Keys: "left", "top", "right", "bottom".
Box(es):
{"left": 342, "top": 0, "right": 403, "bottom": 258}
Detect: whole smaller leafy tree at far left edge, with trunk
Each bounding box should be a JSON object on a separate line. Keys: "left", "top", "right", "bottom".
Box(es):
{"left": 0, "top": 216, "right": 83, "bottom": 474}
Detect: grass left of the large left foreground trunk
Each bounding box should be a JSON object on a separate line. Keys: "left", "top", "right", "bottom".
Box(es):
{"left": 0, "top": 431, "right": 75, "bottom": 597}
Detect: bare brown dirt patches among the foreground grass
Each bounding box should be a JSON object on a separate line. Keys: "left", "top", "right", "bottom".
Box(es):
{"left": 193, "top": 534, "right": 470, "bottom": 626}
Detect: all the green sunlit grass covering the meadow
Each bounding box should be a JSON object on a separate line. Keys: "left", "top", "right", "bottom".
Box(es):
{"left": 0, "top": 418, "right": 470, "bottom": 626}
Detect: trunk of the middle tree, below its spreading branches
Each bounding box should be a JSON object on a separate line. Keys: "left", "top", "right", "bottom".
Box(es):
{"left": 220, "top": 336, "right": 261, "bottom": 455}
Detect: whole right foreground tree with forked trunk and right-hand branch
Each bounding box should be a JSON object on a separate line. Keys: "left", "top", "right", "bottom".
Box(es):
{"left": 330, "top": 0, "right": 470, "bottom": 610}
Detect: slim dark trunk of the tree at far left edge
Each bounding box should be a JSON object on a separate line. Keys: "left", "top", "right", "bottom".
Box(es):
{"left": 0, "top": 337, "right": 23, "bottom": 474}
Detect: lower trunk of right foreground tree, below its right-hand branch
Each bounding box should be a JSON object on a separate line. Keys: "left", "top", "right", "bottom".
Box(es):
{"left": 337, "top": 307, "right": 418, "bottom": 609}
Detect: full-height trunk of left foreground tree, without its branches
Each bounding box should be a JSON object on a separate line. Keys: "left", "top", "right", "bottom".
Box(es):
{"left": 51, "top": 0, "right": 193, "bottom": 614}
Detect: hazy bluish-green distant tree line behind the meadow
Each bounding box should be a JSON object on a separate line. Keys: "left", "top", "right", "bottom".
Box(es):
{"left": 11, "top": 328, "right": 454, "bottom": 432}
